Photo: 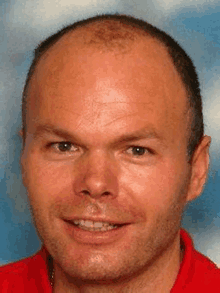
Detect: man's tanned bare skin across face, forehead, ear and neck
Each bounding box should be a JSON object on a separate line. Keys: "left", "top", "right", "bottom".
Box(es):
{"left": 21, "top": 28, "right": 210, "bottom": 292}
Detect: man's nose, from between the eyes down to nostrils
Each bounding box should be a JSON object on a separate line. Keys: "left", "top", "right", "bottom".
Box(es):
{"left": 74, "top": 152, "right": 119, "bottom": 198}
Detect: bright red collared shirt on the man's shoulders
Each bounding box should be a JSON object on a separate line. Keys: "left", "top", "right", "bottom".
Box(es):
{"left": 0, "top": 230, "right": 220, "bottom": 293}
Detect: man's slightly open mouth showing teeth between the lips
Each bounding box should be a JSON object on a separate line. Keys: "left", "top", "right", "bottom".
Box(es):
{"left": 68, "top": 219, "right": 125, "bottom": 232}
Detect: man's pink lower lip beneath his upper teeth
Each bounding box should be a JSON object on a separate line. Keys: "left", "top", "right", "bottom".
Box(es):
{"left": 64, "top": 221, "right": 129, "bottom": 245}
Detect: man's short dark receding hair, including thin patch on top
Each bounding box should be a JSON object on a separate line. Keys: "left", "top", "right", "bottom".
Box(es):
{"left": 22, "top": 14, "right": 204, "bottom": 157}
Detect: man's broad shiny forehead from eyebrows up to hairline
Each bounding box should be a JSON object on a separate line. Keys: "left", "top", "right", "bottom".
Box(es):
{"left": 28, "top": 29, "right": 188, "bottom": 146}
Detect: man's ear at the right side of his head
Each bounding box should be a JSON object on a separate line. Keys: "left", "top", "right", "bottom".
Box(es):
{"left": 187, "top": 135, "right": 211, "bottom": 201}
